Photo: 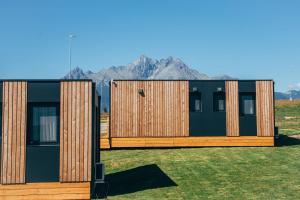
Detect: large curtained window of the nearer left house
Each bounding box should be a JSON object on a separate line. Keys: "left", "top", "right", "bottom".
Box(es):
{"left": 28, "top": 103, "right": 59, "bottom": 144}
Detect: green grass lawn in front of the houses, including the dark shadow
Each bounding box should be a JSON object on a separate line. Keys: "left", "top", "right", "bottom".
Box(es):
{"left": 101, "top": 101, "right": 300, "bottom": 199}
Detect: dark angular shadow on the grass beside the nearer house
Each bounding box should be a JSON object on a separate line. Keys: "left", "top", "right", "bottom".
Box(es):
{"left": 105, "top": 164, "right": 177, "bottom": 196}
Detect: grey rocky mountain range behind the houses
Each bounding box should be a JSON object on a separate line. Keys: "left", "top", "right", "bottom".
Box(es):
{"left": 63, "top": 55, "right": 300, "bottom": 109}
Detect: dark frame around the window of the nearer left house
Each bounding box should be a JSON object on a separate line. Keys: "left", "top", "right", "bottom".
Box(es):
{"left": 26, "top": 102, "right": 60, "bottom": 146}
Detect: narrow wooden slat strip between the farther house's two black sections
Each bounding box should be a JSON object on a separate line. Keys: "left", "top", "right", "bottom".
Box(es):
{"left": 225, "top": 81, "right": 240, "bottom": 136}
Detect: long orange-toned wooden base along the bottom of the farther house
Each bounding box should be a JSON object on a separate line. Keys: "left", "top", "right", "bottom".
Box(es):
{"left": 111, "top": 136, "right": 274, "bottom": 148}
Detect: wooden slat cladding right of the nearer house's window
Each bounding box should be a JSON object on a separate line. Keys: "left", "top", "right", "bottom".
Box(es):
{"left": 60, "top": 81, "right": 92, "bottom": 182}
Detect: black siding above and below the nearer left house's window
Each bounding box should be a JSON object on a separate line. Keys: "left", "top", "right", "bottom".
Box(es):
{"left": 26, "top": 81, "right": 60, "bottom": 183}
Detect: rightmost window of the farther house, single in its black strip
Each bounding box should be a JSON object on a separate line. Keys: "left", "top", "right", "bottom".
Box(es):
{"left": 240, "top": 93, "right": 255, "bottom": 115}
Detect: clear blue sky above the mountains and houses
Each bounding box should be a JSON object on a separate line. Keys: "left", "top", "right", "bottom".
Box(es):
{"left": 0, "top": 0, "right": 300, "bottom": 91}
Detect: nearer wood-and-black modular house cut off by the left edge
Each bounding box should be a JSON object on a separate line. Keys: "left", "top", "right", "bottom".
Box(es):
{"left": 0, "top": 80, "right": 103, "bottom": 199}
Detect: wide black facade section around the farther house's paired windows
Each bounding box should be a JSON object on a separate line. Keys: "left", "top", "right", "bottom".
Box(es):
{"left": 189, "top": 81, "right": 226, "bottom": 136}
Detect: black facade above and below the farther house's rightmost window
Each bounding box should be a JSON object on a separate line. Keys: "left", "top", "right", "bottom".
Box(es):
{"left": 239, "top": 81, "right": 257, "bottom": 136}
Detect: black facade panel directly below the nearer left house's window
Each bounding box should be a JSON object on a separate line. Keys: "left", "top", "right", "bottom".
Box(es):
{"left": 26, "top": 145, "right": 59, "bottom": 183}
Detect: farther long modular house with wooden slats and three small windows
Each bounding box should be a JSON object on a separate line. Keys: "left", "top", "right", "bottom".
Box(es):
{"left": 101, "top": 80, "right": 274, "bottom": 147}
